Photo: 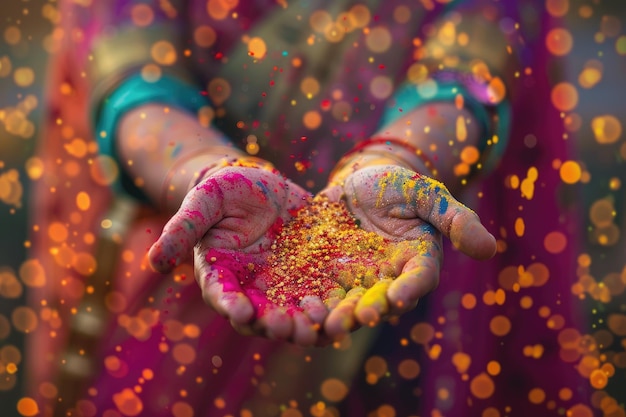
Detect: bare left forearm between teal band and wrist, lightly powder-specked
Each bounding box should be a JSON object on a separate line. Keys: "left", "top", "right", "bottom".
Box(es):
{"left": 116, "top": 104, "right": 245, "bottom": 212}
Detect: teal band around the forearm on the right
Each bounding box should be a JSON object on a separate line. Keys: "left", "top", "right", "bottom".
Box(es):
{"left": 381, "top": 81, "right": 510, "bottom": 170}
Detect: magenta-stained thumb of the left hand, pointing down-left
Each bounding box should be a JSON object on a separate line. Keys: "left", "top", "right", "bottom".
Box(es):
{"left": 148, "top": 179, "right": 223, "bottom": 272}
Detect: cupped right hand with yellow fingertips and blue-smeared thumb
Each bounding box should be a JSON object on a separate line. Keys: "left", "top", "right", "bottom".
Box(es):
{"left": 322, "top": 165, "right": 496, "bottom": 338}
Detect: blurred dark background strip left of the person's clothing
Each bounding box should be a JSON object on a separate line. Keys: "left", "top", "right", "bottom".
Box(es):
{"left": 0, "top": 0, "right": 56, "bottom": 417}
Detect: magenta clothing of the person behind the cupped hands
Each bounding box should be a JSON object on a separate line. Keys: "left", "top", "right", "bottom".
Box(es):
{"left": 30, "top": 0, "right": 589, "bottom": 417}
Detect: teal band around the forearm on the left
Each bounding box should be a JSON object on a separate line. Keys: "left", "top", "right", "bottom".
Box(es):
{"left": 94, "top": 74, "right": 210, "bottom": 201}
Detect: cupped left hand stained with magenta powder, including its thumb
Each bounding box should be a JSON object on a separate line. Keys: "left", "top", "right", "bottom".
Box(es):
{"left": 148, "top": 166, "right": 328, "bottom": 345}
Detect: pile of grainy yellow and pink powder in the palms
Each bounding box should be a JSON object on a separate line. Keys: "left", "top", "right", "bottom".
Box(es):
{"left": 254, "top": 196, "right": 393, "bottom": 307}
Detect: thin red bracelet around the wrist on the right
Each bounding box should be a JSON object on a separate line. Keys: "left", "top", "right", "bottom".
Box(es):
{"left": 329, "top": 137, "right": 437, "bottom": 182}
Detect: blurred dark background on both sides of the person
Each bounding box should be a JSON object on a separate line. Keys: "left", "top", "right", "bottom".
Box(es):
{"left": 0, "top": 0, "right": 626, "bottom": 417}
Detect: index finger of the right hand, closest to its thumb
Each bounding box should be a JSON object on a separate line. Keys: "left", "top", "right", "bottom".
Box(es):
{"left": 387, "top": 242, "right": 441, "bottom": 314}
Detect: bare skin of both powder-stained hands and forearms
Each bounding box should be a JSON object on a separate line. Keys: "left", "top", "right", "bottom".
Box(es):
{"left": 117, "top": 104, "right": 496, "bottom": 346}
